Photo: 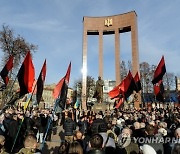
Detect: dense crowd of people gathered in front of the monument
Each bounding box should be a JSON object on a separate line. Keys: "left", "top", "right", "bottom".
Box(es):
{"left": 0, "top": 103, "right": 180, "bottom": 154}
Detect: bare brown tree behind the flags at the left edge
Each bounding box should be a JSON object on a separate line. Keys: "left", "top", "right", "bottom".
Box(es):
{"left": 0, "top": 25, "right": 37, "bottom": 106}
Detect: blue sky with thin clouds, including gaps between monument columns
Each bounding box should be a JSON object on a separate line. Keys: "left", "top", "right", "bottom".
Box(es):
{"left": 0, "top": 0, "right": 180, "bottom": 85}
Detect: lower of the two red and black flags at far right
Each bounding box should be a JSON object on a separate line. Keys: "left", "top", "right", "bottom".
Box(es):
{"left": 154, "top": 80, "right": 164, "bottom": 102}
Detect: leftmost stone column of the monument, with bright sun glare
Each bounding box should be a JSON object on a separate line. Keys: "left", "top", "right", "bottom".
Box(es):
{"left": 81, "top": 30, "right": 87, "bottom": 109}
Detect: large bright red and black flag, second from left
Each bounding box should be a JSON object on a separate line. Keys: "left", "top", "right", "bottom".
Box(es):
{"left": 17, "top": 51, "right": 35, "bottom": 97}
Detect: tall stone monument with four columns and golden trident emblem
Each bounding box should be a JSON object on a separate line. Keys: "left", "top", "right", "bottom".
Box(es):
{"left": 82, "top": 11, "right": 139, "bottom": 109}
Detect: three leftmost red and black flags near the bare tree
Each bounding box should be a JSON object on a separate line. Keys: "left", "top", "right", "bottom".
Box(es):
{"left": 0, "top": 51, "right": 46, "bottom": 106}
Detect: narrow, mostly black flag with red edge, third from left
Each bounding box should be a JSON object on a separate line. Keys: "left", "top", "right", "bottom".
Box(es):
{"left": 36, "top": 60, "right": 46, "bottom": 104}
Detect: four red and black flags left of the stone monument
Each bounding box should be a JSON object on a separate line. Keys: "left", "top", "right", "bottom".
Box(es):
{"left": 0, "top": 51, "right": 71, "bottom": 110}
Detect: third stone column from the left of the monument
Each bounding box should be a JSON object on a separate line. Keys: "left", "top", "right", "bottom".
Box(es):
{"left": 115, "top": 29, "right": 121, "bottom": 85}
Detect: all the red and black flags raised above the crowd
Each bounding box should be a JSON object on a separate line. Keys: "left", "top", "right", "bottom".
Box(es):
{"left": 0, "top": 51, "right": 166, "bottom": 109}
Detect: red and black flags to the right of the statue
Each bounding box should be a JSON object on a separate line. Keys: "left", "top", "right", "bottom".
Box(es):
{"left": 108, "top": 56, "right": 166, "bottom": 108}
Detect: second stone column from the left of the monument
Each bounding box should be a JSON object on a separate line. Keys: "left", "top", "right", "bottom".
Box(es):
{"left": 99, "top": 30, "right": 103, "bottom": 79}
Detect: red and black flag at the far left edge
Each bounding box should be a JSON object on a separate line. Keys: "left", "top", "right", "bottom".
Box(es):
{"left": 0, "top": 56, "right": 13, "bottom": 86}
